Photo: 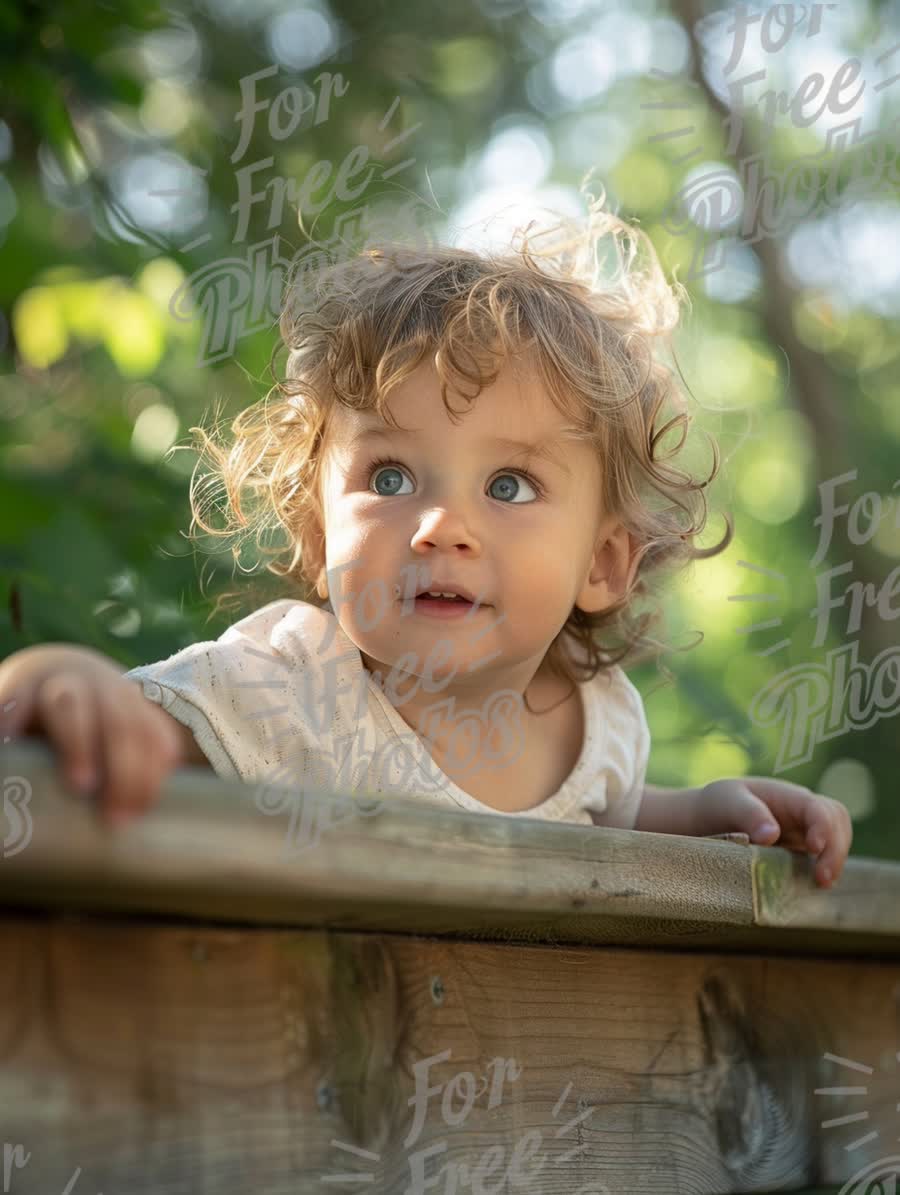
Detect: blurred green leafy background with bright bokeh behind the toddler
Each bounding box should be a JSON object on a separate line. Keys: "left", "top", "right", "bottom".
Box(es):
{"left": 0, "top": 0, "right": 900, "bottom": 858}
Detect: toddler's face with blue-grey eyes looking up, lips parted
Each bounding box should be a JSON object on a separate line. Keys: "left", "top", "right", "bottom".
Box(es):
{"left": 323, "top": 361, "right": 627, "bottom": 679}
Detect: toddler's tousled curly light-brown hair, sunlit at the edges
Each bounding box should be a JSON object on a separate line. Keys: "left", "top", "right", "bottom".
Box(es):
{"left": 191, "top": 190, "right": 734, "bottom": 697}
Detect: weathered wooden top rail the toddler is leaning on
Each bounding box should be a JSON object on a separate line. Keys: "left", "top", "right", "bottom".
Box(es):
{"left": 0, "top": 740, "right": 900, "bottom": 956}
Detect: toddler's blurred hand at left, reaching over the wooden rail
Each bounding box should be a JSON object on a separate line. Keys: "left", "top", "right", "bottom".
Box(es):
{"left": 0, "top": 644, "right": 185, "bottom": 822}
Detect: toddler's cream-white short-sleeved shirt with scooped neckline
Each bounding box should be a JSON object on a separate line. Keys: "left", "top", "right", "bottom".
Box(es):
{"left": 124, "top": 599, "right": 650, "bottom": 829}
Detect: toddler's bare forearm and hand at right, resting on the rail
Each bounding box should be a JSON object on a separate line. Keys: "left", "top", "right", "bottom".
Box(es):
{"left": 635, "top": 776, "right": 853, "bottom": 888}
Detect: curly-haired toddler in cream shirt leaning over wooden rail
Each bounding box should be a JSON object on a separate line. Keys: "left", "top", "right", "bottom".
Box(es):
{"left": 0, "top": 195, "right": 851, "bottom": 887}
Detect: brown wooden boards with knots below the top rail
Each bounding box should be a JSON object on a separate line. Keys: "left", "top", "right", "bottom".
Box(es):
{"left": 0, "top": 913, "right": 900, "bottom": 1195}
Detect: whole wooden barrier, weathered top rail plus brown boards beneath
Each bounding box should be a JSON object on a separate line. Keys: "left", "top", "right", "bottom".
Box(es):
{"left": 0, "top": 740, "right": 900, "bottom": 1195}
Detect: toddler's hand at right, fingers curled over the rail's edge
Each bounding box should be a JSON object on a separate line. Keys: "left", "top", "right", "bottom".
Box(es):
{"left": 698, "top": 776, "right": 853, "bottom": 888}
